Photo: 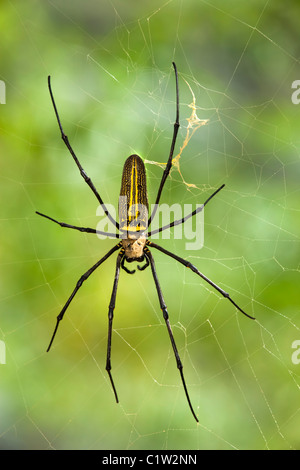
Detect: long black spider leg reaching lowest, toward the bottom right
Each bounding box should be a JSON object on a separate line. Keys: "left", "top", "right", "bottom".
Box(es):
{"left": 144, "top": 247, "right": 199, "bottom": 423}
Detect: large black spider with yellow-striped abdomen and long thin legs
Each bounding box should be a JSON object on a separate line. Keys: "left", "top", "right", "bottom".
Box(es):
{"left": 36, "top": 62, "right": 254, "bottom": 422}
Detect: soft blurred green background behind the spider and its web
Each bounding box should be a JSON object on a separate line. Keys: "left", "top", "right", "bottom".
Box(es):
{"left": 0, "top": 0, "right": 300, "bottom": 449}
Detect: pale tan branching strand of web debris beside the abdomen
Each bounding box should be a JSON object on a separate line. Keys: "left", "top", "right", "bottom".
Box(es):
{"left": 145, "top": 79, "right": 209, "bottom": 189}
